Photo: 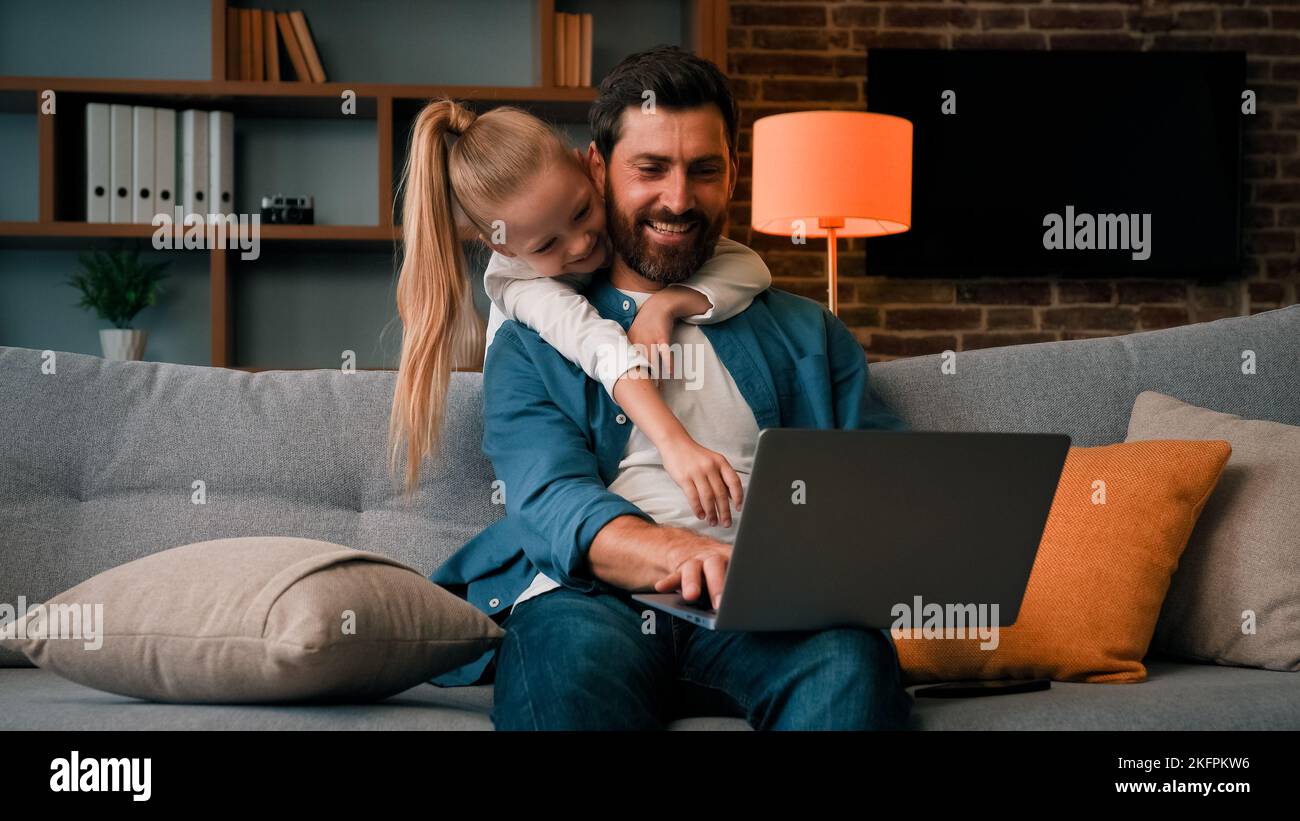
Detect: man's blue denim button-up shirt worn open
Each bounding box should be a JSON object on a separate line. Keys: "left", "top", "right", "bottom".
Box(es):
{"left": 429, "top": 273, "right": 906, "bottom": 686}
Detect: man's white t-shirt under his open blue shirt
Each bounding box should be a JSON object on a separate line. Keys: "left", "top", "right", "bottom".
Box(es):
{"left": 510, "top": 288, "right": 758, "bottom": 612}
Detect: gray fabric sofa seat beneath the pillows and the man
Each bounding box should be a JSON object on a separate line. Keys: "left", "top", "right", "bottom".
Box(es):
{"left": 0, "top": 659, "right": 1300, "bottom": 731}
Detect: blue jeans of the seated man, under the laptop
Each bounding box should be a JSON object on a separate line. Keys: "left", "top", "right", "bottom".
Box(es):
{"left": 485, "top": 587, "right": 913, "bottom": 730}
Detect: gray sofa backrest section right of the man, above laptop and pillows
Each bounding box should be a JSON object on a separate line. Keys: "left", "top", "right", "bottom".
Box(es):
{"left": 871, "top": 305, "right": 1300, "bottom": 447}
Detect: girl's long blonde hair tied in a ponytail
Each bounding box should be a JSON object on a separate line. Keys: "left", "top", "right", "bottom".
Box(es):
{"left": 389, "top": 100, "right": 568, "bottom": 500}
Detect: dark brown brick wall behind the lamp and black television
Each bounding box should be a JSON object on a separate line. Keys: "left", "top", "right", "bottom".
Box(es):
{"left": 727, "top": 0, "right": 1300, "bottom": 361}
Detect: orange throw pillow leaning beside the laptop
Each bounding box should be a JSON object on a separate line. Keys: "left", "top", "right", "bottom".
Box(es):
{"left": 893, "top": 439, "right": 1232, "bottom": 686}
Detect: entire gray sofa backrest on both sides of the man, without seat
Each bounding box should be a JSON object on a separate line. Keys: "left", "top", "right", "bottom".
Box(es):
{"left": 0, "top": 305, "right": 1300, "bottom": 665}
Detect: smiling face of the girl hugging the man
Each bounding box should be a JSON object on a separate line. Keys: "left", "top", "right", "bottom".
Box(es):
{"left": 484, "top": 152, "right": 610, "bottom": 277}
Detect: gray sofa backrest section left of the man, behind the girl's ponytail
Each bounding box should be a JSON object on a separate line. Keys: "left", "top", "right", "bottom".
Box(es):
{"left": 0, "top": 347, "right": 502, "bottom": 664}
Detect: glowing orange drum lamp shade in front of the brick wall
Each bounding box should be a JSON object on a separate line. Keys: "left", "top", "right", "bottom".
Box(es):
{"left": 750, "top": 112, "right": 911, "bottom": 236}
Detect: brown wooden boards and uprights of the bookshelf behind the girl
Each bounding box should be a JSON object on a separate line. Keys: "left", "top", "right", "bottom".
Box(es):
{"left": 0, "top": 0, "right": 727, "bottom": 372}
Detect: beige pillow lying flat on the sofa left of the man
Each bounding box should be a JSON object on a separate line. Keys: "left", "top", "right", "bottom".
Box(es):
{"left": 0, "top": 537, "right": 504, "bottom": 703}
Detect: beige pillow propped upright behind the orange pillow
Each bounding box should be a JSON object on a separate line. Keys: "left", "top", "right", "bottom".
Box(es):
{"left": 1128, "top": 387, "right": 1300, "bottom": 670}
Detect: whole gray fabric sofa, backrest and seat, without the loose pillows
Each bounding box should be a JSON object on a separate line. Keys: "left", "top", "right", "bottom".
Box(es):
{"left": 0, "top": 305, "right": 1300, "bottom": 730}
